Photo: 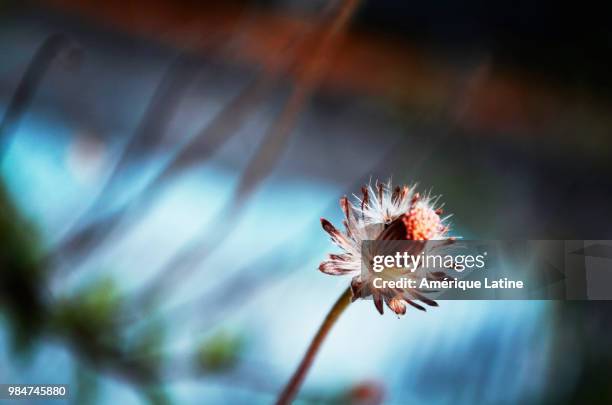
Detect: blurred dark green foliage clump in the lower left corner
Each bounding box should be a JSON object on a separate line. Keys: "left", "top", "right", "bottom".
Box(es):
{"left": 0, "top": 179, "right": 169, "bottom": 404}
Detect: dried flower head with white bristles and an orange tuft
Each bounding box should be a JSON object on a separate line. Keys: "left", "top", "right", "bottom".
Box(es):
{"left": 319, "top": 181, "right": 454, "bottom": 315}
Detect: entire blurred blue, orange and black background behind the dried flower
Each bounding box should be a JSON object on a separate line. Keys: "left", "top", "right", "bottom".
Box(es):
{"left": 0, "top": 0, "right": 612, "bottom": 404}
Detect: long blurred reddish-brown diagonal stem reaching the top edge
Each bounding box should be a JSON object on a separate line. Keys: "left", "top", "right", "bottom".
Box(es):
{"left": 134, "top": 0, "right": 358, "bottom": 307}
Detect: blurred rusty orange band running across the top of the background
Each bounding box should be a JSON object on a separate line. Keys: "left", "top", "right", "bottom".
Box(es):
{"left": 47, "top": 0, "right": 612, "bottom": 151}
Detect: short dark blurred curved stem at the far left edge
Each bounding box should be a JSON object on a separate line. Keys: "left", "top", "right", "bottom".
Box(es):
{"left": 0, "top": 34, "right": 76, "bottom": 161}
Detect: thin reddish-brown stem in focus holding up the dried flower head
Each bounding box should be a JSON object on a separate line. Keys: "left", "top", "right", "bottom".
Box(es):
{"left": 276, "top": 287, "right": 353, "bottom": 405}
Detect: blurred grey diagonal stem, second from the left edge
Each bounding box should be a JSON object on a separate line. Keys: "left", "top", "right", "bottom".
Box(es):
{"left": 45, "top": 54, "right": 198, "bottom": 263}
